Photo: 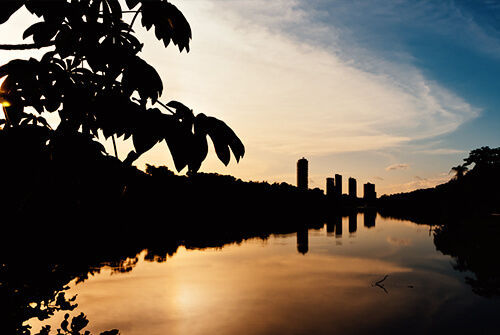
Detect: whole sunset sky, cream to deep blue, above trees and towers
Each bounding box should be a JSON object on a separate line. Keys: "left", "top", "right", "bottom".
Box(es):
{"left": 0, "top": 0, "right": 500, "bottom": 195}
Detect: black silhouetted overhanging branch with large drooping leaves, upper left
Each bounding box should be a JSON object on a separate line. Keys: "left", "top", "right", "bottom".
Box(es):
{"left": 0, "top": 0, "right": 245, "bottom": 178}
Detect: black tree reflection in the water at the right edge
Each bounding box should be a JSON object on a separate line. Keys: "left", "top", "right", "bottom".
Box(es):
{"left": 434, "top": 219, "right": 500, "bottom": 298}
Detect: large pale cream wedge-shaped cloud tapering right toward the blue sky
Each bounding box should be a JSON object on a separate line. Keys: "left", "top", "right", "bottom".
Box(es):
{"left": 146, "top": 1, "right": 478, "bottom": 154}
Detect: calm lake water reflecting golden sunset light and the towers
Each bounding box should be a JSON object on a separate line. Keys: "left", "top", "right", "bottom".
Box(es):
{"left": 26, "top": 214, "right": 500, "bottom": 335}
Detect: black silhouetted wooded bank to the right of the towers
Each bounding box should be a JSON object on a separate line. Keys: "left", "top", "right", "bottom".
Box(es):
{"left": 377, "top": 147, "right": 500, "bottom": 223}
